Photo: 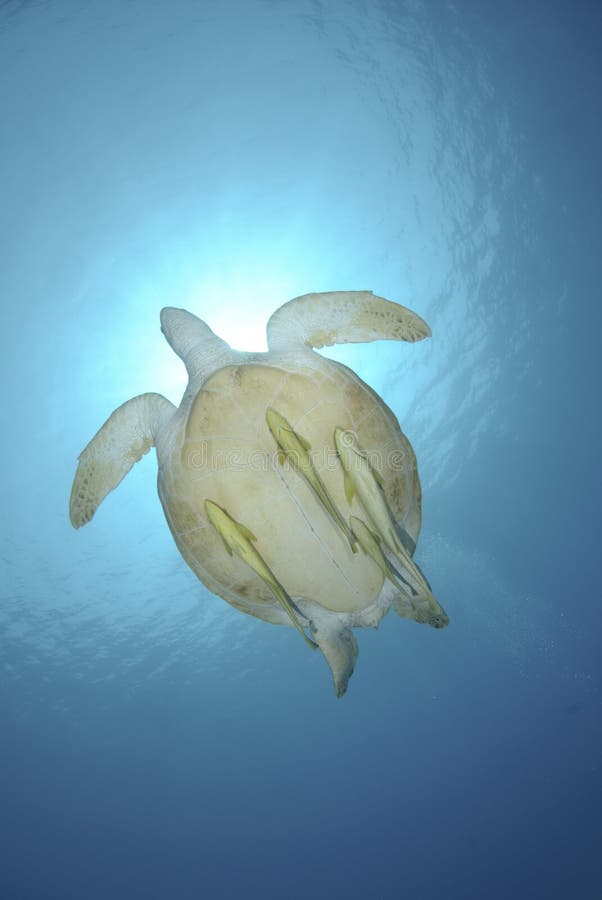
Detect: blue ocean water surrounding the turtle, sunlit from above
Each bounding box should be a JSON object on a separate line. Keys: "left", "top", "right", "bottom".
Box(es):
{"left": 0, "top": 0, "right": 602, "bottom": 900}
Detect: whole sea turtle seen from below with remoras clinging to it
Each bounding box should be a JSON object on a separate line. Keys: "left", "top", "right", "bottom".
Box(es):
{"left": 70, "top": 291, "right": 448, "bottom": 696}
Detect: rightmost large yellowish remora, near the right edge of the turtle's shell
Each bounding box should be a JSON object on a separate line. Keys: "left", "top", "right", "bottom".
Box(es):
{"left": 334, "top": 428, "right": 437, "bottom": 603}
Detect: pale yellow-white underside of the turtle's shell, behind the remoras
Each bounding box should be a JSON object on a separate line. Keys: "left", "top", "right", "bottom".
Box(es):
{"left": 159, "top": 354, "right": 421, "bottom": 622}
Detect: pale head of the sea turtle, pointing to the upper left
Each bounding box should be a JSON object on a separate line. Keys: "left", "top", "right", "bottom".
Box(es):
{"left": 161, "top": 306, "right": 231, "bottom": 378}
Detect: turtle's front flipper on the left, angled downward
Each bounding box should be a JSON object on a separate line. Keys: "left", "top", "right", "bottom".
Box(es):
{"left": 69, "top": 394, "right": 175, "bottom": 528}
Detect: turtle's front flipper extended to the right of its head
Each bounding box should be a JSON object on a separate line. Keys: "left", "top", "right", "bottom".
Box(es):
{"left": 268, "top": 291, "right": 431, "bottom": 352}
